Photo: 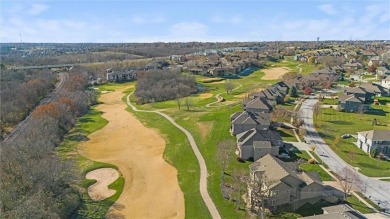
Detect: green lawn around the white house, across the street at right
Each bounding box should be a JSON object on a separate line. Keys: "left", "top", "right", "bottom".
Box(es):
{"left": 314, "top": 97, "right": 390, "bottom": 177}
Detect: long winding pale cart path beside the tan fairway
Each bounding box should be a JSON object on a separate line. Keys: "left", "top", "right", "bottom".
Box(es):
{"left": 126, "top": 92, "right": 221, "bottom": 218}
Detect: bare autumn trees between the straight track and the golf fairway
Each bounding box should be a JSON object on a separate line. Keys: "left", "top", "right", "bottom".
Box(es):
{"left": 0, "top": 70, "right": 96, "bottom": 218}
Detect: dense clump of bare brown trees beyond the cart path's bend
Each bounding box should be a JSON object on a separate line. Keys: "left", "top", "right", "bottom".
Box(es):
{"left": 135, "top": 71, "right": 197, "bottom": 104}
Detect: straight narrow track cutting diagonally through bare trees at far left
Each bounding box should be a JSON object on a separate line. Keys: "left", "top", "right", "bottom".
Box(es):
{"left": 3, "top": 72, "right": 69, "bottom": 143}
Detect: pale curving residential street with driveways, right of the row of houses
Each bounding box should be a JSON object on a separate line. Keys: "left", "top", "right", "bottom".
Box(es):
{"left": 299, "top": 96, "right": 390, "bottom": 213}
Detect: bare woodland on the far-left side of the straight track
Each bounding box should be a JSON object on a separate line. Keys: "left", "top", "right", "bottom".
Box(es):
{"left": 0, "top": 69, "right": 56, "bottom": 137}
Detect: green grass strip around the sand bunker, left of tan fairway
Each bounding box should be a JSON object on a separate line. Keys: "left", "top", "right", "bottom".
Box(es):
{"left": 57, "top": 107, "right": 124, "bottom": 218}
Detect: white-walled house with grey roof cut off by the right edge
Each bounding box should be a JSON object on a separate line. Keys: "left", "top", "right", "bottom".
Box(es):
{"left": 357, "top": 130, "right": 390, "bottom": 155}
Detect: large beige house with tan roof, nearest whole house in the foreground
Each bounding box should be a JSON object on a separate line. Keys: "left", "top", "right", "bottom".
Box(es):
{"left": 248, "top": 154, "right": 324, "bottom": 209}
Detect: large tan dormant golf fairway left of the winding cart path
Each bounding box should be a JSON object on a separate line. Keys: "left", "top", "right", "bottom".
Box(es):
{"left": 79, "top": 87, "right": 185, "bottom": 218}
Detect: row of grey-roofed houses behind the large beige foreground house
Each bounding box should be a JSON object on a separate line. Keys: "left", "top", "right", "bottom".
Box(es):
{"left": 230, "top": 82, "right": 290, "bottom": 161}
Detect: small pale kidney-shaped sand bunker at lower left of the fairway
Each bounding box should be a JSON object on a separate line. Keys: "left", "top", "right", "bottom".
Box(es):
{"left": 85, "top": 168, "right": 119, "bottom": 201}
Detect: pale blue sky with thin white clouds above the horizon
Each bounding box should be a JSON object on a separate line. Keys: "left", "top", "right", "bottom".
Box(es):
{"left": 0, "top": 0, "right": 390, "bottom": 43}
